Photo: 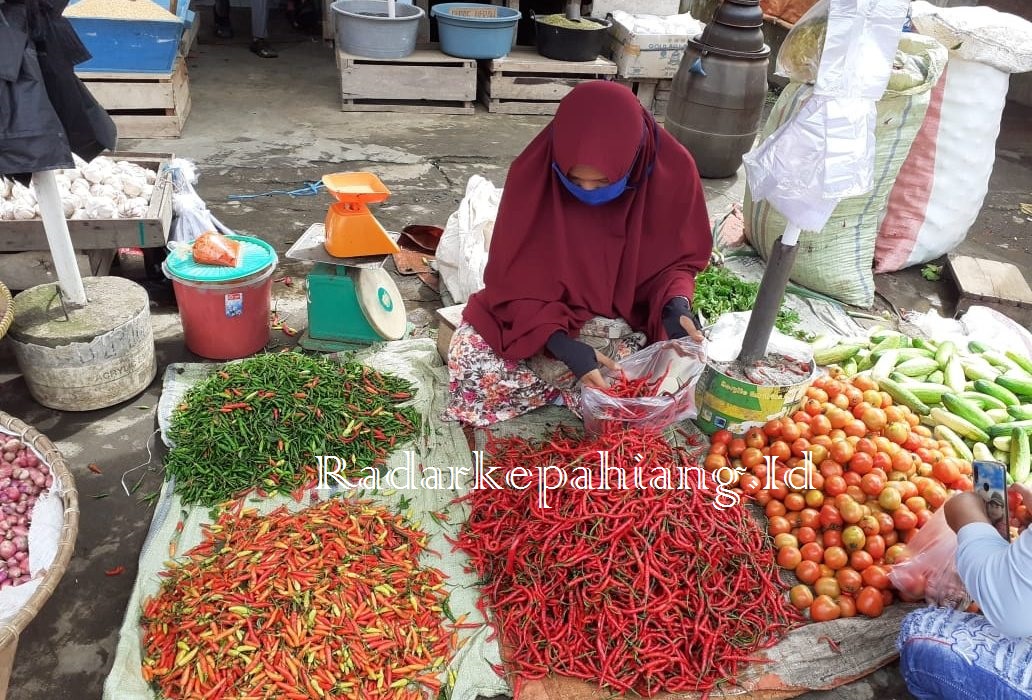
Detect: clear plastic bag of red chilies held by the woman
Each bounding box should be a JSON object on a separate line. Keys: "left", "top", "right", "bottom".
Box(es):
{"left": 580, "top": 338, "right": 706, "bottom": 435}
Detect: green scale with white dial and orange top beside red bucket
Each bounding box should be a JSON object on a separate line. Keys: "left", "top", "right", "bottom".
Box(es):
{"left": 287, "top": 172, "right": 408, "bottom": 352}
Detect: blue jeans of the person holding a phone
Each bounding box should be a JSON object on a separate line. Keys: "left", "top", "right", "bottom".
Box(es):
{"left": 897, "top": 607, "right": 1032, "bottom": 700}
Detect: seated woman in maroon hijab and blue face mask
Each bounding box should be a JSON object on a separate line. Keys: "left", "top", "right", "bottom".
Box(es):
{"left": 447, "top": 81, "right": 712, "bottom": 425}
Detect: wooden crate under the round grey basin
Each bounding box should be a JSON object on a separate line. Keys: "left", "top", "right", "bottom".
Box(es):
{"left": 336, "top": 49, "right": 477, "bottom": 115}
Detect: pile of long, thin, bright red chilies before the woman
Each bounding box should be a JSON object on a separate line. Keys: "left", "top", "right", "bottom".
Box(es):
{"left": 457, "top": 431, "right": 802, "bottom": 700}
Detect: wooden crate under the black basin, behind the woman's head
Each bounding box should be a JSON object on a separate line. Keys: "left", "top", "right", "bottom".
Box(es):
{"left": 480, "top": 49, "right": 616, "bottom": 115}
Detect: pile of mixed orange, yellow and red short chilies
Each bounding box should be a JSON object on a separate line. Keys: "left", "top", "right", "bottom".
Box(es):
{"left": 141, "top": 499, "right": 457, "bottom": 700}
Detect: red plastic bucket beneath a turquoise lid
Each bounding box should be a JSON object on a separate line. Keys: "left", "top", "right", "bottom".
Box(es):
{"left": 165, "top": 262, "right": 276, "bottom": 359}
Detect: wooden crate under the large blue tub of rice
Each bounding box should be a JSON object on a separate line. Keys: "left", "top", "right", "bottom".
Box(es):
{"left": 78, "top": 56, "right": 190, "bottom": 138}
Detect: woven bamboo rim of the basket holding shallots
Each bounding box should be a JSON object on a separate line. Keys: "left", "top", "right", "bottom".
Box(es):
{"left": 0, "top": 410, "right": 78, "bottom": 700}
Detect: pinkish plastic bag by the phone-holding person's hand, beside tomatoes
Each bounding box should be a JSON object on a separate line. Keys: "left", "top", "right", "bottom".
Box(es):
{"left": 889, "top": 508, "right": 971, "bottom": 610}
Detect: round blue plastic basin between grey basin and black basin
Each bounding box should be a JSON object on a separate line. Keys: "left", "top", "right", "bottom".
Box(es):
{"left": 430, "top": 2, "right": 521, "bottom": 59}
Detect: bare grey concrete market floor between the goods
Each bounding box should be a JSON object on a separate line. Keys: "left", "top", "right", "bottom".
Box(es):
{"left": 0, "top": 10, "right": 1032, "bottom": 700}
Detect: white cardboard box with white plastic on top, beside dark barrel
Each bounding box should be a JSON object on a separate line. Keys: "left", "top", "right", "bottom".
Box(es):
{"left": 609, "top": 12, "right": 703, "bottom": 79}
